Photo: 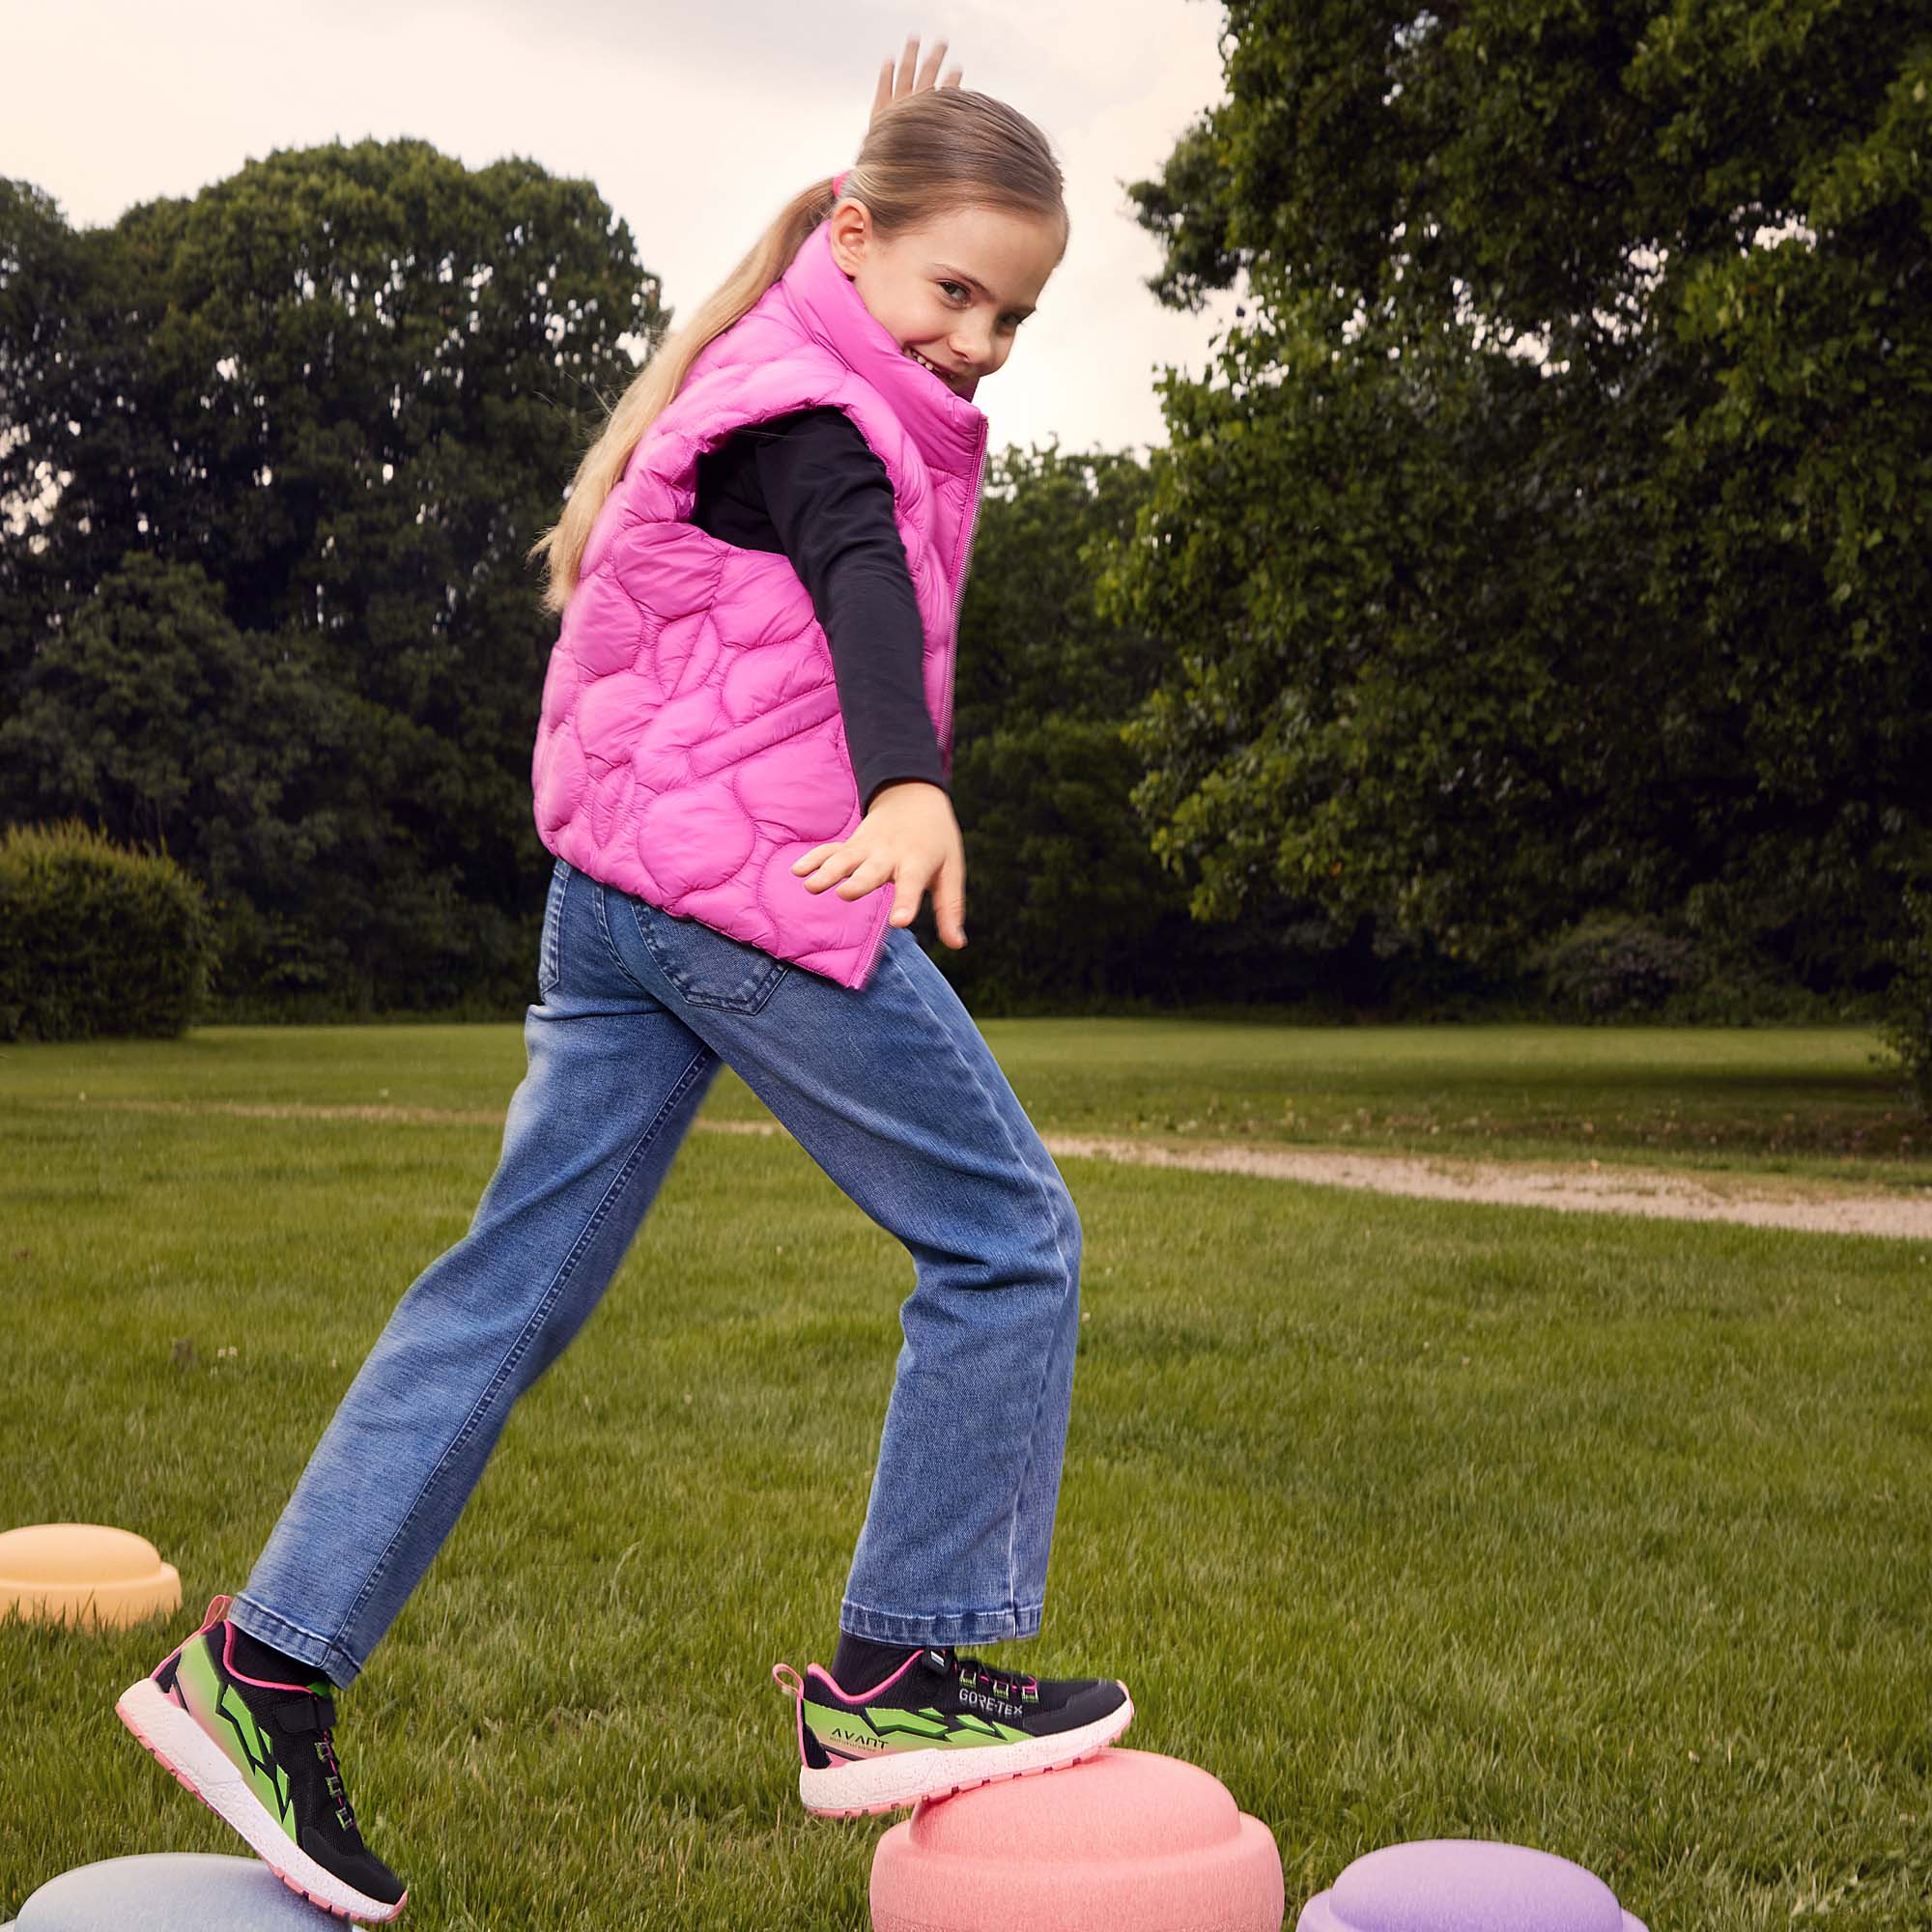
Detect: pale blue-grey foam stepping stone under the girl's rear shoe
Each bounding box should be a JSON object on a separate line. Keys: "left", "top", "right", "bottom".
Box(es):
{"left": 12, "top": 1851, "right": 365, "bottom": 1932}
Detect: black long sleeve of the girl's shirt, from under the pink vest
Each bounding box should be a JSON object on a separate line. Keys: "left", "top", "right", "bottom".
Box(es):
{"left": 692, "top": 408, "right": 947, "bottom": 810}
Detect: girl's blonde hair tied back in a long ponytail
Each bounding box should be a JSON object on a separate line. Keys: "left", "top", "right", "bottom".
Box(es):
{"left": 527, "top": 87, "right": 1068, "bottom": 612}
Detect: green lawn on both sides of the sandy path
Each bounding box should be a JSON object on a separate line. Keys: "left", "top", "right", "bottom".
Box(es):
{"left": 0, "top": 1020, "right": 1932, "bottom": 1932}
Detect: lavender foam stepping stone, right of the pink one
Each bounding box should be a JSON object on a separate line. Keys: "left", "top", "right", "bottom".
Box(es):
{"left": 1298, "top": 1837, "right": 1644, "bottom": 1932}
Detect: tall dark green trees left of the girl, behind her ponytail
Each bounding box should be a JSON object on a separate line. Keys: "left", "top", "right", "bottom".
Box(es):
{"left": 0, "top": 141, "right": 667, "bottom": 1003}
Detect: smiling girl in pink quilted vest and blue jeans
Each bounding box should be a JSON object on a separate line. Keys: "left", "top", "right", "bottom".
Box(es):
{"left": 118, "top": 56, "right": 1132, "bottom": 1920}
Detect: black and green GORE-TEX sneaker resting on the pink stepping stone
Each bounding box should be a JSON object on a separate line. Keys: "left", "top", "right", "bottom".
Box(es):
{"left": 771, "top": 1644, "right": 1134, "bottom": 1818}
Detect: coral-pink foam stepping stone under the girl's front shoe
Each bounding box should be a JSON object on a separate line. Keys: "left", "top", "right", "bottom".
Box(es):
{"left": 871, "top": 1747, "right": 1283, "bottom": 1932}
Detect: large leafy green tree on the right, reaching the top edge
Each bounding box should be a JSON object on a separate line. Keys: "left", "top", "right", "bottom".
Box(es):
{"left": 1103, "top": 0, "right": 1932, "bottom": 981}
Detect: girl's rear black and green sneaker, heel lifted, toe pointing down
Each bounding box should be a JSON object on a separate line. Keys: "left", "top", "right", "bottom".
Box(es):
{"left": 114, "top": 1596, "right": 408, "bottom": 1924}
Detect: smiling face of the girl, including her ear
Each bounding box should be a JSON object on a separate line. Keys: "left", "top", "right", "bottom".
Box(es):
{"left": 831, "top": 201, "right": 1066, "bottom": 396}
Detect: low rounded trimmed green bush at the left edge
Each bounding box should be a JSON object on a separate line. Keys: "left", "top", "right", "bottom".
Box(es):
{"left": 0, "top": 819, "right": 213, "bottom": 1039}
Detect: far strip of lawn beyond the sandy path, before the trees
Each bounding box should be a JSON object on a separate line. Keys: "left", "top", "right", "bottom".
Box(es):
{"left": 4, "top": 1018, "right": 1932, "bottom": 1192}
